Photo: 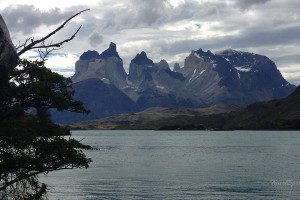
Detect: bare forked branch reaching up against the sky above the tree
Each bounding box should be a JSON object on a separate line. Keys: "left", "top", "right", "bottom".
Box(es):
{"left": 17, "top": 9, "right": 90, "bottom": 56}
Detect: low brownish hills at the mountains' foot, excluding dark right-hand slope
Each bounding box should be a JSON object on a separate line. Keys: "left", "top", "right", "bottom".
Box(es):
{"left": 69, "top": 104, "right": 243, "bottom": 130}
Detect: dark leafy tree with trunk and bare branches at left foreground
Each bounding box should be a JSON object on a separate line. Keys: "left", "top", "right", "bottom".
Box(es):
{"left": 0, "top": 12, "right": 91, "bottom": 199}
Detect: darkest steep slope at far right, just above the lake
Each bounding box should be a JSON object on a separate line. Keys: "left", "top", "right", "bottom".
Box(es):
{"left": 223, "top": 86, "right": 300, "bottom": 130}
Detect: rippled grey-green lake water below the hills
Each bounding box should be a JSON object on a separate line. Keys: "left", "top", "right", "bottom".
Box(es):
{"left": 41, "top": 131, "right": 300, "bottom": 200}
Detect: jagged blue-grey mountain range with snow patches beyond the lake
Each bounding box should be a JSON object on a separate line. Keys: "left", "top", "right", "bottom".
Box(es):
{"left": 52, "top": 43, "right": 296, "bottom": 124}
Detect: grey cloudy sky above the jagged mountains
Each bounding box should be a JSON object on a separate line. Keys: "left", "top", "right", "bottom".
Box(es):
{"left": 0, "top": 0, "right": 300, "bottom": 85}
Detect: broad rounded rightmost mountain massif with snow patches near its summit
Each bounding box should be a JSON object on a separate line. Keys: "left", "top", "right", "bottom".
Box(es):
{"left": 177, "top": 49, "right": 295, "bottom": 104}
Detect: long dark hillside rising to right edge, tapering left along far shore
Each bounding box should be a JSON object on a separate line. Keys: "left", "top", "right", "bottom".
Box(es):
{"left": 147, "top": 86, "right": 300, "bottom": 130}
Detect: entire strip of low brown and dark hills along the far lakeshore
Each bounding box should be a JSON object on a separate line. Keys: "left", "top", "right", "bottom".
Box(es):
{"left": 71, "top": 86, "right": 300, "bottom": 130}
